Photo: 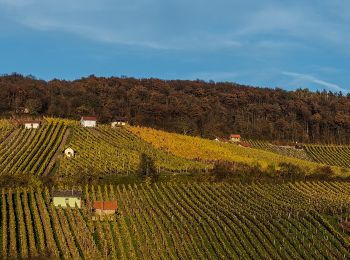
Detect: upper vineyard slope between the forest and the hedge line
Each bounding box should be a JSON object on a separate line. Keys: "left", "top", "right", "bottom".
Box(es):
{"left": 0, "top": 118, "right": 350, "bottom": 184}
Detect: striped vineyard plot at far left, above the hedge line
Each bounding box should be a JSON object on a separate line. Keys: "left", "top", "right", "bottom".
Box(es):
{"left": 0, "top": 122, "right": 67, "bottom": 176}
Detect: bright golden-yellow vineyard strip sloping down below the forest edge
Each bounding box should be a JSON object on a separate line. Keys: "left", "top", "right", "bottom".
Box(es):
{"left": 129, "top": 127, "right": 344, "bottom": 175}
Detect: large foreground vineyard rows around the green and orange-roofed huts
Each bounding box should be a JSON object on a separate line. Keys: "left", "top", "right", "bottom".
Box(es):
{"left": 0, "top": 182, "right": 350, "bottom": 259}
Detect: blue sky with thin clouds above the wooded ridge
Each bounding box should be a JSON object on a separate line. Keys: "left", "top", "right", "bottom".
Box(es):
{"left": 0, "top": 0, "right": 350, "bottom": 93}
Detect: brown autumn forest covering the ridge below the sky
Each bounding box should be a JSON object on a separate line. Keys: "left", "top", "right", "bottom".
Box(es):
{"left": 0, "top": 74, "right": 350, "bottom": 143}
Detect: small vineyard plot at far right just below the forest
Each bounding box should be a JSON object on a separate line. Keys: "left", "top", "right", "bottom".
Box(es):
{"left": 305, "top": 145, "right": 350, "bottom": 168}
